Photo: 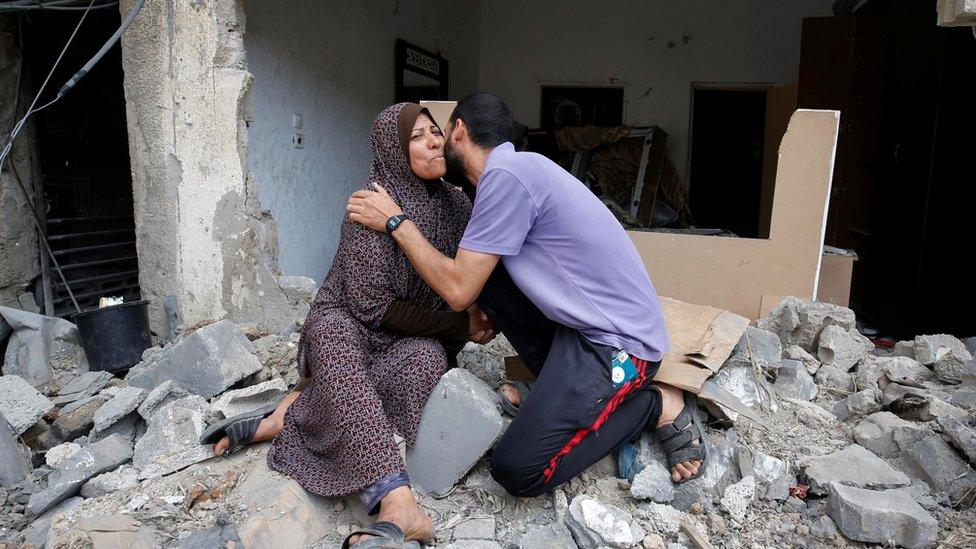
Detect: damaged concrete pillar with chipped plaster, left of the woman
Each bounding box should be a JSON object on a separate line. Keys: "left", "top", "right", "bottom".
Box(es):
{"left": 120, "top": 0, "right": 294, "bottom": 334}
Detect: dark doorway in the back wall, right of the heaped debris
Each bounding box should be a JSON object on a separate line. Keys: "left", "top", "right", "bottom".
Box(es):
{"left": 688, "top": 84, "right": 768, "bottom": 238}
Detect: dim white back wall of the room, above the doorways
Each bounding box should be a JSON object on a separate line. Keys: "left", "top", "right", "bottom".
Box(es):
{"left": 479, "top": 0, "right": 832, "bottom": 184}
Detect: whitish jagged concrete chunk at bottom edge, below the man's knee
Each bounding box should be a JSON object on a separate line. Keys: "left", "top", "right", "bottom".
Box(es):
{"left": 566, "top": 495, "right": 644, "bottom": 549}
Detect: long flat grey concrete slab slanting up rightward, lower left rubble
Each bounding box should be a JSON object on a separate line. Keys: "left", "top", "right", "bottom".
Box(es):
{"left": 27, "top": 435, "right": 132, "bottom": 516}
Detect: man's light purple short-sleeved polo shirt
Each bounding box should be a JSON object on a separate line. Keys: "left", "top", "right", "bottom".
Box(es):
{"left": 461, "top": 143, "right": 670, "bottom": 361}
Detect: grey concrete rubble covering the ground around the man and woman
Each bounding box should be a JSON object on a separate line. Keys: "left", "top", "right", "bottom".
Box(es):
{"left": 0, "top": 294, "right": 976, "bottom": 549}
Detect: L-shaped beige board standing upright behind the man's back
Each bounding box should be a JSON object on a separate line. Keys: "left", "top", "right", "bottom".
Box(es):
{"left": 628, "top": 109, "right": 840, "bottom": 320}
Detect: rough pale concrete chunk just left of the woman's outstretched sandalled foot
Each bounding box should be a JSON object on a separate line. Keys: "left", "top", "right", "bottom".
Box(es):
{"left": 132, "top": 395, "right": 213, "bottom": 479}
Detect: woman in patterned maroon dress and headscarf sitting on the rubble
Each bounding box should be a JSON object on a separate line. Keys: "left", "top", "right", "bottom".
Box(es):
{"left": 201, "top": 103, "right": 490, "bottom": 547}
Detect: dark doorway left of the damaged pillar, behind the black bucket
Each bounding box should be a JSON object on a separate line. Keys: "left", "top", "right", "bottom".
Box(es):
{"left": 21, "top": 10, "right": 139, "bottom": 316}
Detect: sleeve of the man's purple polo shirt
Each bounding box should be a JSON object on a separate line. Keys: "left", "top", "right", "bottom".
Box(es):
{"left": 460, "top": 170, "right": 539, "bottom": 255}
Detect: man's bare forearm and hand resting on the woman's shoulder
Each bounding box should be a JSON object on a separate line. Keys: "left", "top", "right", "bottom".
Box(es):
{"left": 346, "top": 183, "right": 498, "bottom": 311}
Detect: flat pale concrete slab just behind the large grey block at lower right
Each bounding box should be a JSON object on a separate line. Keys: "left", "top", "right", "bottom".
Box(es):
{"left": 797, "top": 444, "right": 912, "bottom": 495}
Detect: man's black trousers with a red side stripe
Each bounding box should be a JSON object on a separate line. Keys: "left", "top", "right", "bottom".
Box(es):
{"left": 478, "top": 264, "right": 661, "bottom": 497}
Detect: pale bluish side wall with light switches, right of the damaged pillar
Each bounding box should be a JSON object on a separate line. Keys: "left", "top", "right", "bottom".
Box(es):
{"left": 244, "top": 0, "right": 480, "bottom": 282}
